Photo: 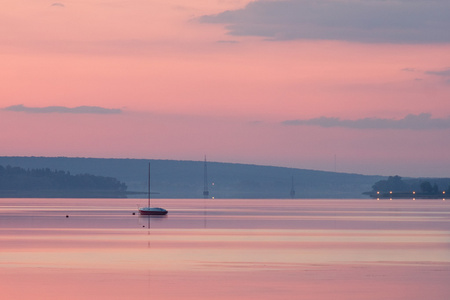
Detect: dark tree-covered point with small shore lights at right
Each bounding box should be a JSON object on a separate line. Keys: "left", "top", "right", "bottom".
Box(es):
{"left": 370, "top": 176, "right": 450, "bottom": 198}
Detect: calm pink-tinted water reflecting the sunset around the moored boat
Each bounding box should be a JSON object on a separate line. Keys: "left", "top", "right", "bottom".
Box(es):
{"left": 0, "top": 199, "right": 450, "bottom": 300}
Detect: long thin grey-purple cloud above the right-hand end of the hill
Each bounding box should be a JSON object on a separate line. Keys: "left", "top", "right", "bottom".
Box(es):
{"left": 282, "top": 113, "right": 450, "bottom": 130}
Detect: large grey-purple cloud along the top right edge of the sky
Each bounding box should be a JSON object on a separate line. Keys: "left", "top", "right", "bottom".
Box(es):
{"left": 199, "top": 0, "right": 450, "bottom": 44}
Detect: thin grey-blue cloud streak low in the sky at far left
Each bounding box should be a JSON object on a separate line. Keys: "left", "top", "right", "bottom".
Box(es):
{"left": 3, "top": 104, "right": 122, "bottom": 115}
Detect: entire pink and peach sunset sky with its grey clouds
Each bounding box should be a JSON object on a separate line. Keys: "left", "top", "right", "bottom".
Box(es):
{"left": 0, "top": 0, "right": 450, "bottom": 177}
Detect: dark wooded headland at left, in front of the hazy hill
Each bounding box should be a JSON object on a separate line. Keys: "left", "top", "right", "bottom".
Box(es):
{"left": 0, "top": 165, "right": 127, "bottom": 197}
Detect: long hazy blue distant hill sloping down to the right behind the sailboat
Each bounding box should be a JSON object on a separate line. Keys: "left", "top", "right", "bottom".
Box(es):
{"left": 0, "top": 156, "right": 386, "bottom": 199}
